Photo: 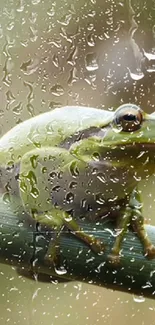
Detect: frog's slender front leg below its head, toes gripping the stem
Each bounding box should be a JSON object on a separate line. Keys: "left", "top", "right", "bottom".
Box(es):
{"left": 109, "top": 189, "right": 155, "bottom": 264}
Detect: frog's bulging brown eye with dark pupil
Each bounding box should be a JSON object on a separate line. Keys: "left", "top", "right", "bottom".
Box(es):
{"left": 114, "top": 104, "right": 143, "bottom": 132}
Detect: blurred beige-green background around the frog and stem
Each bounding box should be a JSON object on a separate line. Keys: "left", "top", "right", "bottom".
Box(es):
{"left": 0, "top": 0, "right": 155, "bottom": 325}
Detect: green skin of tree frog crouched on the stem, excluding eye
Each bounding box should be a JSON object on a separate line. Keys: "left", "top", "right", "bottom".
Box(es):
{"left": 0, "top": 104, "right": 155, "bottom": 262}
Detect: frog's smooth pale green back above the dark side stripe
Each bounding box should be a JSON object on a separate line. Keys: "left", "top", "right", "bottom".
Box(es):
{"left": 0, "top": 106, "right": 112, "bottom": 163}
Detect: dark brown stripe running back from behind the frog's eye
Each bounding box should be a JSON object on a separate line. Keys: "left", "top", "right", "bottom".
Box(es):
{"left": 59, "top": 126, "right": 109, "bottom": 149}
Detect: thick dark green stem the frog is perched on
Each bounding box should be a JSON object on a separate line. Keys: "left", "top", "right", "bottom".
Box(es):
{"left": 0, "top": 198, "right": 155, "bottom": 298}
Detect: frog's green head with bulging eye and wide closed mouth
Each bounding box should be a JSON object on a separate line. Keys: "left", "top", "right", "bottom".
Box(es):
{"left": 95, "top": 104, "right": 155, "bottom": 174}
